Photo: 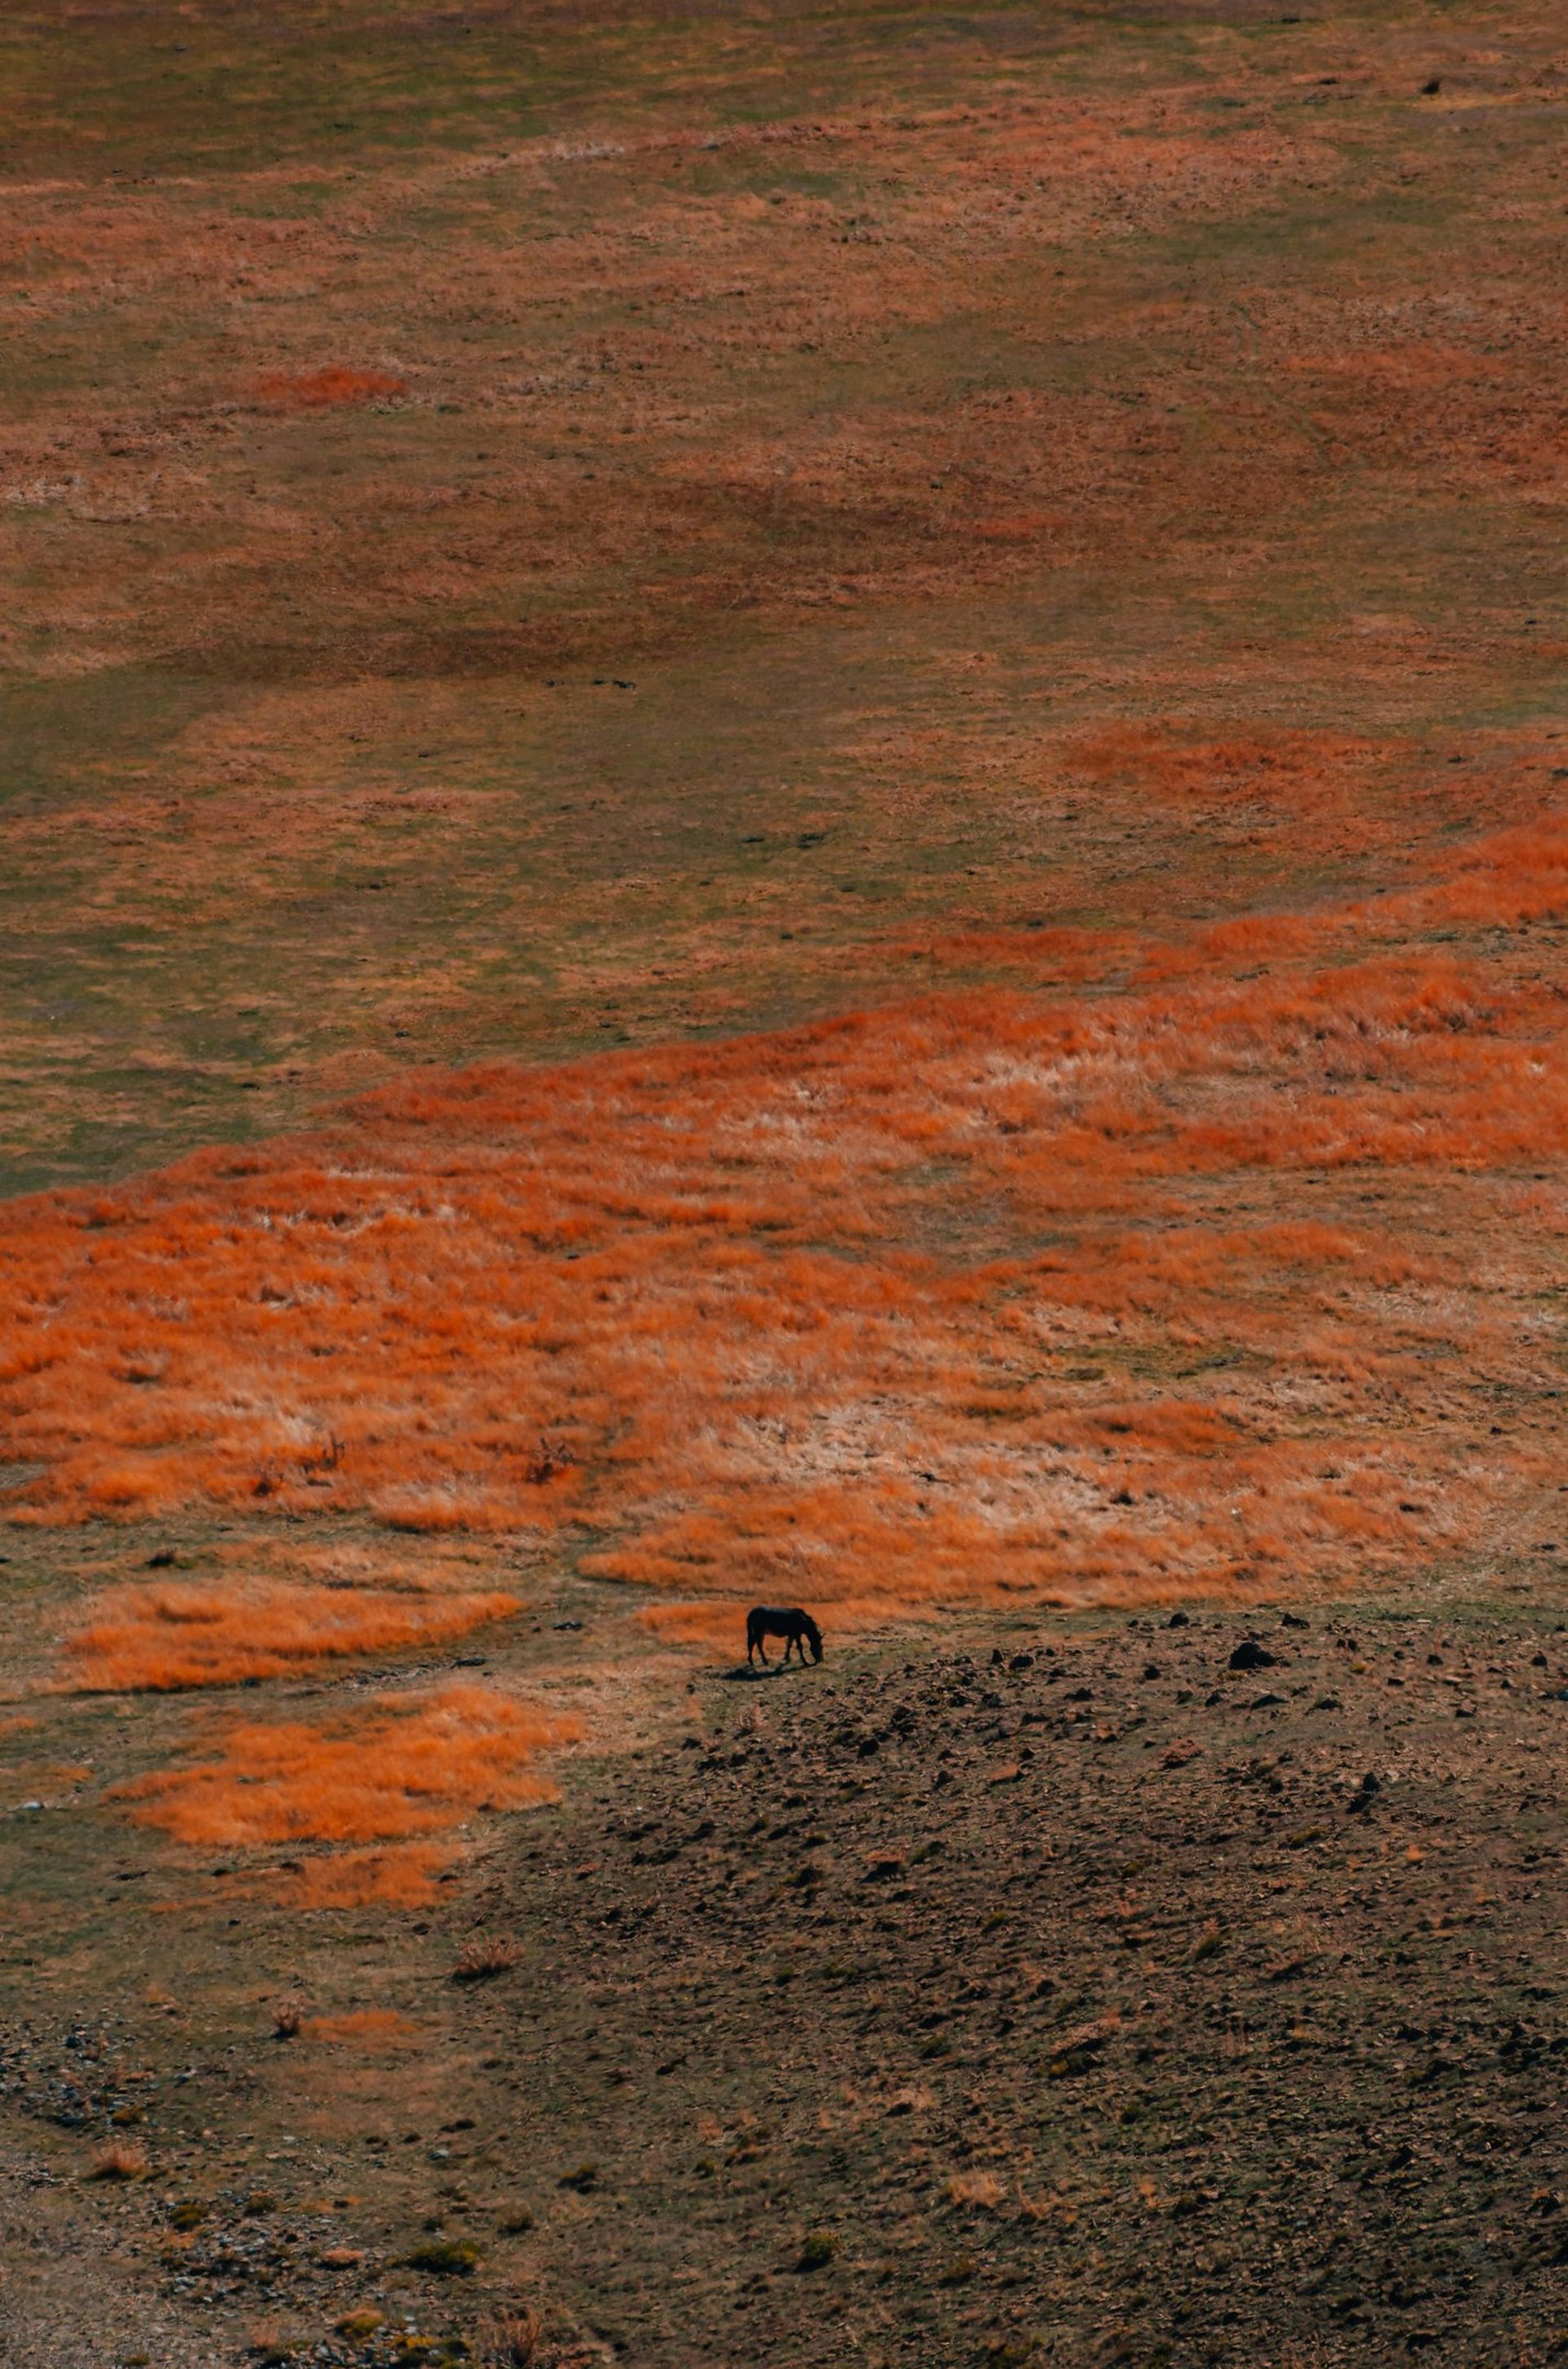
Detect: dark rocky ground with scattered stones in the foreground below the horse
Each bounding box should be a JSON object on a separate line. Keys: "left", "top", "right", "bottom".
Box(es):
{"left": 0, "top": 1608, "right": 1568, "bottom": 2369}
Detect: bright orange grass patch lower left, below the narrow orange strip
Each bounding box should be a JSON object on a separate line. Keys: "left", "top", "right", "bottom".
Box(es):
{"left": 111, "top": 1684, "right": 581, "bottom": 1864}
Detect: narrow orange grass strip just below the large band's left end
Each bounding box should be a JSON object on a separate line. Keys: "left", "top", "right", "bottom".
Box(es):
{"left": 66, "top": 1580, "right": 521, "bottom": 1694}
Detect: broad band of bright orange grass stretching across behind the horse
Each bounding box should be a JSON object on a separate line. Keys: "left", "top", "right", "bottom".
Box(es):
{"left": 0, "top": 822, "right": 1568, "bottom": 1620}
